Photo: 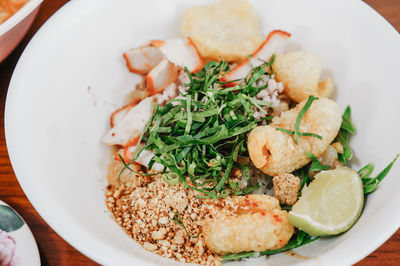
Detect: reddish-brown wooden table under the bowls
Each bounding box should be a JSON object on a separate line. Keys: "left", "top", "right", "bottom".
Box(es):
{"left": 0, "top": 0, "right": 400, "bottom": 265}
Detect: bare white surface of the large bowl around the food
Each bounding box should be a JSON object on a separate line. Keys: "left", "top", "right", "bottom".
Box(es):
{"left": 5, "top": 0, "right": 400, "bottom": 265}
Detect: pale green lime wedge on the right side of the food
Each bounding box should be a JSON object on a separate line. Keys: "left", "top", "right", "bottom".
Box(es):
{"left": 289, "top": 166, "right": 364, "bottom": 236}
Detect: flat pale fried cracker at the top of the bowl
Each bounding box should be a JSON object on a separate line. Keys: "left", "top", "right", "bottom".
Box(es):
{"left": 181, "top": 0, "right": 264, "bottom": 62}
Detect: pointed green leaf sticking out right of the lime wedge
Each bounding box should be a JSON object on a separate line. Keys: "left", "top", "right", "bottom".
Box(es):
{"left": 358, "top": 154, "right": 400, "bottom": 195}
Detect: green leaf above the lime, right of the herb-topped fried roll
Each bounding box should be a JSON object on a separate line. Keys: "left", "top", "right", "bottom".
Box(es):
{"left": 334, "top": 106, "right": 356, "bottom": 165}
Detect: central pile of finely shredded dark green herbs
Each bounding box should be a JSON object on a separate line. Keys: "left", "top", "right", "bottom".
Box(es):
{"left": 123, "top": 56, "right": 275, "bottom": 199}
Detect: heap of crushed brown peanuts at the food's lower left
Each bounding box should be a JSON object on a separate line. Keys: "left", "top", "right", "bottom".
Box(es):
{"left": 106, "top": 176, "right": 241, "bottom": 265}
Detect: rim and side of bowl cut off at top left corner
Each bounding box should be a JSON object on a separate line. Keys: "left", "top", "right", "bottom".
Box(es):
{"left": 0, "top": 0, "right": 43, "bottom": 63}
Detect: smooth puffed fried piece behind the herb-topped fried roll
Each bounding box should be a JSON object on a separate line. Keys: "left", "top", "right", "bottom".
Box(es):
{"left": 272, "top": 51, "right": 333, "bottom": 102}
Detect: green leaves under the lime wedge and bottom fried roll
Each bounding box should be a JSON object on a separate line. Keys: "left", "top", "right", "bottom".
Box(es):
{"left": 222, "top": 230, "right": 319, "bottom": 260}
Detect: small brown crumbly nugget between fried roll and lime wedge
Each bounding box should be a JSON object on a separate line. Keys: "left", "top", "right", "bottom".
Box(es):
{"left": 272, "top": 174, "right": 300, "bottom": 205}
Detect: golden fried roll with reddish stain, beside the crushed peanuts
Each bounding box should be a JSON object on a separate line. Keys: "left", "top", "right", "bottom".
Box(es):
{"left": 203, "top": 195, "right": 294, "bottom": 255}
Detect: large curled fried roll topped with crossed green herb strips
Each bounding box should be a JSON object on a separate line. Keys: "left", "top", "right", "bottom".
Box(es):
{"left": 247, "top": 98, "right": 342, "bottom": 176}
